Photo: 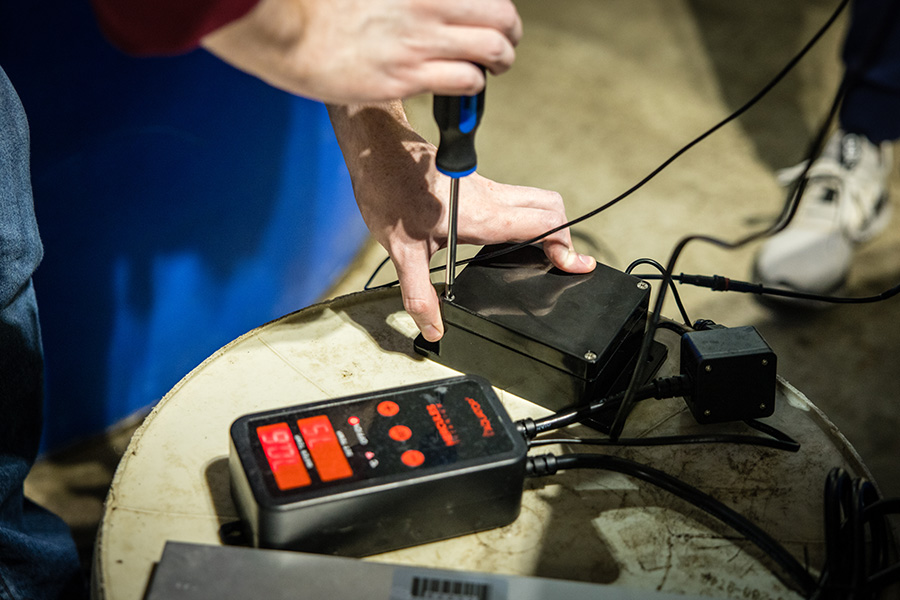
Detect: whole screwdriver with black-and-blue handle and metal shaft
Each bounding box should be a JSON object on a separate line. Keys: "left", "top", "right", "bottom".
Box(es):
{"left": 434, "top": 76, "right": 484, "bottom": 301}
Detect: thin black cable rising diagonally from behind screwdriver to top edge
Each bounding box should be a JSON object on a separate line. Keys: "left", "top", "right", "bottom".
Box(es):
{"left": 362, "top": 0, "right": 850, "bottom": 290}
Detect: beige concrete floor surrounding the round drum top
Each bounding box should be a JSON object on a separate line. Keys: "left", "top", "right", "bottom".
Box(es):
{"left": 28, "top": 0, "right": 900, "bottom": 580}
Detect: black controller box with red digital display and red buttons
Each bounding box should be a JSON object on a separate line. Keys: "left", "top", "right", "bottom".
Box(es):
{"left": 229, "top": 376, "right": 527, "bottom": 556}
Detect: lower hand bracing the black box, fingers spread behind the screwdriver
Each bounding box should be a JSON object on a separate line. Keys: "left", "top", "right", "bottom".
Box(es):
{"left": 329, "top": 102, "right": 596, "bottom": 341}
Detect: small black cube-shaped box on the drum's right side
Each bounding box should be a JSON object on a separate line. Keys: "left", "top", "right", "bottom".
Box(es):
{"left": 681, "top": 325, "right": 777, "bottom": 424}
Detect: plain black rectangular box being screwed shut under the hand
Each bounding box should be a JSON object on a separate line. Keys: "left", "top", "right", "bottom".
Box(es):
{"left": 414, "top": 246, "right": 666, "bottom": 410}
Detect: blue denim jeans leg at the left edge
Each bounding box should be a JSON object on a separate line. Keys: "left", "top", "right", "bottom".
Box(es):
{"left": 0, "top": 68, "right": 83, "bottom": 600}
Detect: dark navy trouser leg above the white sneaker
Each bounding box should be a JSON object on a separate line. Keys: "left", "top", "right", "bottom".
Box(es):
{"left": 840, "top": 0, "right": 900, "bottom": 144}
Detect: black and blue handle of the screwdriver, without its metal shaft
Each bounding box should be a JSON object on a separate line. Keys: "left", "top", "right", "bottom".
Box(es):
{"left": 434, "top": 78, "right": 484, "bottom": 178}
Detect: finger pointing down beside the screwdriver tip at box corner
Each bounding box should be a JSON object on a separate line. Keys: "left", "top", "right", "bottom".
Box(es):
{"left": 391, "top": 243, "right": 444, "bottom": 342}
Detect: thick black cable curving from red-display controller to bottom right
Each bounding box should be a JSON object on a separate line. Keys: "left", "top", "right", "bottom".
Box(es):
{"left": 526, "top": 454, "right": 816, "bottom": 596}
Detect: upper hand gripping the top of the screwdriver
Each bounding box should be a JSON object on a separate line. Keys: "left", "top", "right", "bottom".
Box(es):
{"left": 201, "top": 0, "right": 522, "bottom": 104}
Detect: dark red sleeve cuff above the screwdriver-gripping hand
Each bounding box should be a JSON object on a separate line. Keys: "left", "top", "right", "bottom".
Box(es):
{"left": 91, "top": 0, "right": 259, "bottom": 56}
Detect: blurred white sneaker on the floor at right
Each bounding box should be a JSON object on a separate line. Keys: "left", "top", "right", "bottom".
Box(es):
{"left": 753, "top": 131, "right": 892, "bottom": 294}
